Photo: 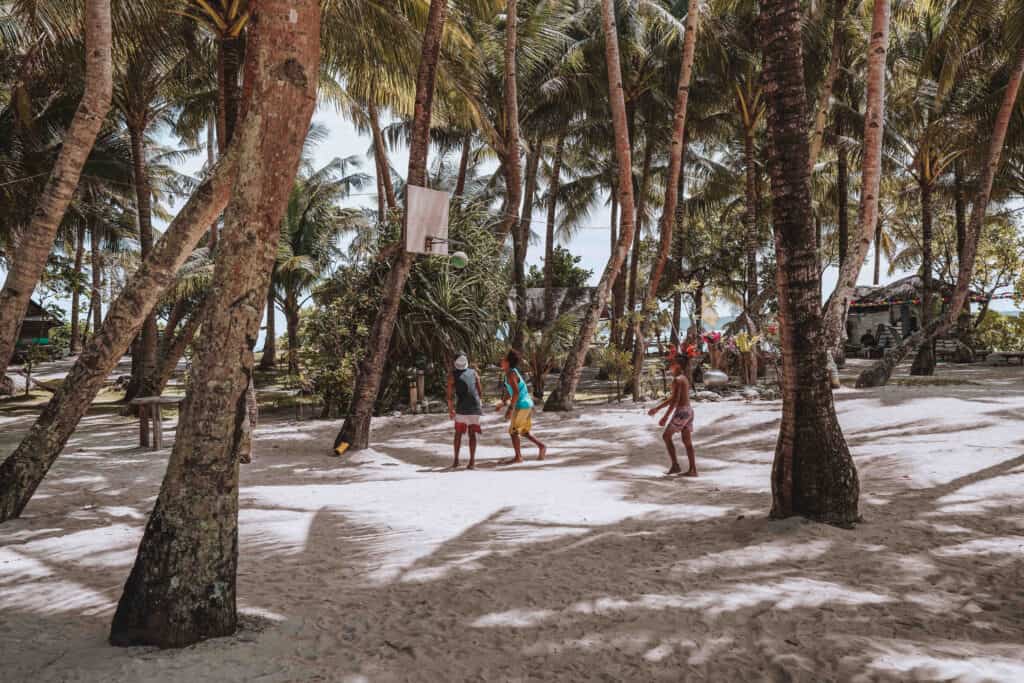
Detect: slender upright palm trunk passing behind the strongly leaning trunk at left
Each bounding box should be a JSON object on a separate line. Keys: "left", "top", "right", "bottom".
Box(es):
{"left": 125, "top": 119, "right": 158, "bottom": 411}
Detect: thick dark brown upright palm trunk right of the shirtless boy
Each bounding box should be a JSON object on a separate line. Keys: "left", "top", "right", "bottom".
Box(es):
{"left": 760, "top": 0, "right": 859, "bottom": 525}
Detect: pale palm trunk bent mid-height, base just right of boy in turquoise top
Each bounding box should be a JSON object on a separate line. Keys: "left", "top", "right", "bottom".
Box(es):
{"left": 544, "top": 0, "right": 635, "bottom": 411}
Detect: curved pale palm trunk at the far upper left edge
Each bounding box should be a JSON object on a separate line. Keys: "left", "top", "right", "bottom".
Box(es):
{"left": 0, "top": 0, "right": 114, "bottom": 378}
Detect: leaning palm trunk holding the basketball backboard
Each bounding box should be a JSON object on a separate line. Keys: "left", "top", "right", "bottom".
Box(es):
{"left": 335, "top": 0, "right": 447, "bottom": 449}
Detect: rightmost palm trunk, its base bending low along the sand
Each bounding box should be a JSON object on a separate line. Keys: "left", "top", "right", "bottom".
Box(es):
{"left": 857, "top": 42, "right": 1024, "bottom": 387}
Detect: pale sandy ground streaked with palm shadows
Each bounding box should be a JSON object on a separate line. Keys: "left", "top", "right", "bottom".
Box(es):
{"left": 0, "top": 366, "right": 1024, "bottom": 682}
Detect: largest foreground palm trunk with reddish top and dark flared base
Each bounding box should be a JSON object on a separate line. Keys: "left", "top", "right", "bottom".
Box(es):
{"left": 110, "top": 0, "right": 321, "bottom": 647}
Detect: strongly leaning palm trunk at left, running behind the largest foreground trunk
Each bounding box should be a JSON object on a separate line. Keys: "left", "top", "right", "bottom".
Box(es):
{"left": 0, "top": 136, "right": 238, "bottom": 522}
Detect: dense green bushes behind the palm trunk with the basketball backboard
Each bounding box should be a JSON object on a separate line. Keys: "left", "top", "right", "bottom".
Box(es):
{"left": 300, "top": 200, "right": 507, "bottom": 415}
